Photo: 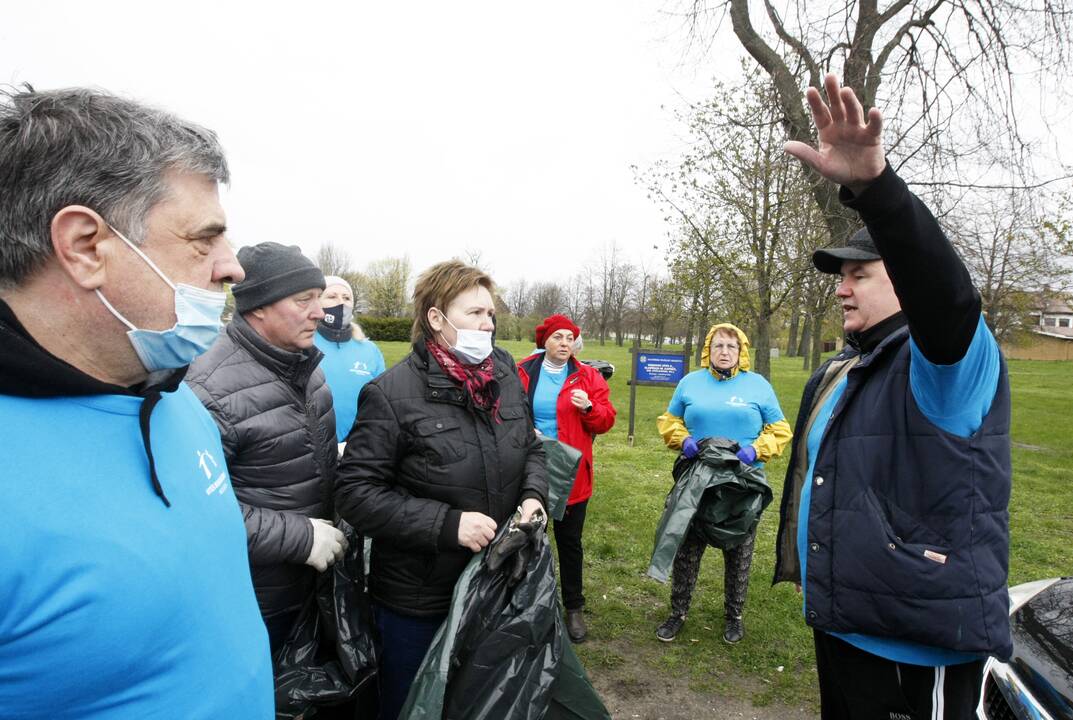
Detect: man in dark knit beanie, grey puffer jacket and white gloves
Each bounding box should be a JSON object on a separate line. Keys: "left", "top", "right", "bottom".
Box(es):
{"left": 187, "top": 243, "right": 346, "bottom": 655}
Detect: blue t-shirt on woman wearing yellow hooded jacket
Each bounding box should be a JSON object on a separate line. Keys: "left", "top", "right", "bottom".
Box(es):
{"left": 667, "top": 368, "right": 783, "bottom": 457}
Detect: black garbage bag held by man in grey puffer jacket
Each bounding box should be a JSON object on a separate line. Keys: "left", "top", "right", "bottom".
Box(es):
{"left": 273, "top": 520, "right": 376, "bottom": 720}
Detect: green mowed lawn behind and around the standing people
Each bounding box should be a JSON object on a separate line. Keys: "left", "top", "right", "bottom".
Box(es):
{"left": 371, "top": 342, "right": 1073, "bottom": 706}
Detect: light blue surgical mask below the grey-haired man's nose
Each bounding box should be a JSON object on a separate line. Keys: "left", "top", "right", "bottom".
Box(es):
{"left": 94, "top": 225, "right": 227, "bottom": 372}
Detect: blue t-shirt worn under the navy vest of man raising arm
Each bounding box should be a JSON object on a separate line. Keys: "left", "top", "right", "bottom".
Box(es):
{"left": 797, "top": 315, "right": 1000, "bottom": 666}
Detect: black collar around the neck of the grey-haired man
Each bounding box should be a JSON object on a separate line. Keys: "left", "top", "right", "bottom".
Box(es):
{"left": 0, "top": 300, "right": 187, "bottom": 398}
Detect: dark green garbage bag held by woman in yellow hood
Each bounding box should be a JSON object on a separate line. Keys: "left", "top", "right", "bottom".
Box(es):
{"left": 647, "top": 438, "right": 771, "bottom": 583}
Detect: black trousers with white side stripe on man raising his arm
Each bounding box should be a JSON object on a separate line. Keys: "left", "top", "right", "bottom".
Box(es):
{"left": 812, "top": 630, "right": 984, "bottom": 720}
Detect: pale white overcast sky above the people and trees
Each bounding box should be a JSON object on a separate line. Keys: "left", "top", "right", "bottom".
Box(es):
{"left": 0, "top": 0, "right": 737, "bottom": 283}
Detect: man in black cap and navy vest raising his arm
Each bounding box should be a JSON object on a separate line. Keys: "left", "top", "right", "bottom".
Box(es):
{"left": 775, "top": 75, "right": 1012, "bottom": 720}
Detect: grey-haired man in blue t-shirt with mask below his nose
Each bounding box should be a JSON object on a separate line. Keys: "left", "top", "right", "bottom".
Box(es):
{"left": 0, "top": 87, "right": 274, "bottom": 718}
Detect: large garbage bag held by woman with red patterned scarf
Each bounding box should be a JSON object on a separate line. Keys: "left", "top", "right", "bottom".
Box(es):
{"left": 399, "top": 506, "right": 611, "bottom": 720}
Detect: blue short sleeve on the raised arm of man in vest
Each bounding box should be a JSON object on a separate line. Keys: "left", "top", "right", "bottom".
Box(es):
{"left": 909, "top": 315, "right": 1001, "bottom": 438}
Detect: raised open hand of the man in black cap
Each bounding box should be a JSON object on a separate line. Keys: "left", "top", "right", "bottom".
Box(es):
{"left": 783, "top": 74, "right": 886, "bottom": 194}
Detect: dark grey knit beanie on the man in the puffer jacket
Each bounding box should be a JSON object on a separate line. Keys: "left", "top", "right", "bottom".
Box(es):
{"left": 231, "top": 243, "right": 324, "bottom": 312}
